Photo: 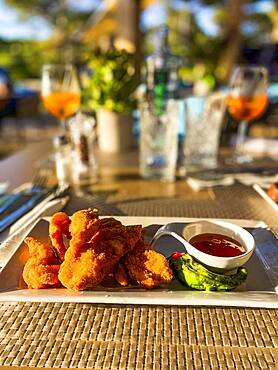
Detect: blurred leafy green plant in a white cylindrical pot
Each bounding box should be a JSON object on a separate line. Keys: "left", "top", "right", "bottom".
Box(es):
{"left": 85, "top": 49, "right": 138, "bottom": 153}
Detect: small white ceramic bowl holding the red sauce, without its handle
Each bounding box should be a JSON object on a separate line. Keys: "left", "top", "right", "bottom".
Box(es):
{"left": 182, "top": 221, "right": 255, "bottom": 272}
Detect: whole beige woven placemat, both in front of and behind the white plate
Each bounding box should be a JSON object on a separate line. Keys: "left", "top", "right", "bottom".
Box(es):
{"left": 0, "top": 184, "right": 278, "bottom": 370}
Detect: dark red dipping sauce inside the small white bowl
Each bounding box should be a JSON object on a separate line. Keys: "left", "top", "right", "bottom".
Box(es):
{"left": 189, "top": 233, "right": 245, "bottom": 257}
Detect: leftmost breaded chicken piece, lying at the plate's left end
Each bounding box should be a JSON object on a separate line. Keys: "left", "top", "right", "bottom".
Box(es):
{"left": 23, "top": 237, "right": 61, "bottom": 289}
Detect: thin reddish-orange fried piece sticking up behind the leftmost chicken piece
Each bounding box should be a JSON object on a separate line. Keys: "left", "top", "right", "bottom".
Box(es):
{"left": 49, "top": 212, "right": 71, "bottom": 262}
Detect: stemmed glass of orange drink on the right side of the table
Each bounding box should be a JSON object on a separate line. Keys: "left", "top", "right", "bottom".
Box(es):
{"left": 227, "top": 66, "right": 268, "bottom": 163}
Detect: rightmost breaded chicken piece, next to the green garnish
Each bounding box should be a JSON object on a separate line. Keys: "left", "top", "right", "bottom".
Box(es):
{"left": 122, "top": 239, "right": 173, "bottom": 289}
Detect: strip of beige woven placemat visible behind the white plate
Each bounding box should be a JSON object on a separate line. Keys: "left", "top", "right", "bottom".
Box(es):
{"left": 66, "top": 180, "right": 278, "bottom": 234}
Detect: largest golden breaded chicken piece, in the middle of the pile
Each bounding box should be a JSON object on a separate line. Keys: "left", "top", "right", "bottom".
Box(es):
{"left": 59, "top": 209, "right": 142, "bottom": 290}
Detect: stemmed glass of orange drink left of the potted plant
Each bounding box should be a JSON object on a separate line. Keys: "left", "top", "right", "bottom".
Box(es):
{"left": 42, "top": 64, "right": 80, "bottom": 133}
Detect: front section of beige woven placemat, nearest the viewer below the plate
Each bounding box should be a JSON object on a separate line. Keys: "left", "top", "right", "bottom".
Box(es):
{"left": 0, "top": 303, "right": 278, "bottom": 370}
